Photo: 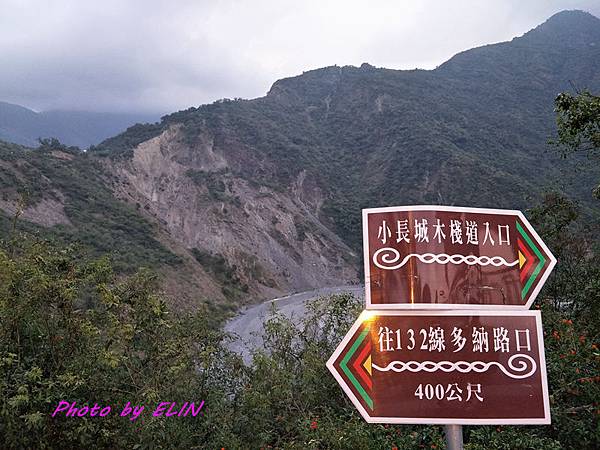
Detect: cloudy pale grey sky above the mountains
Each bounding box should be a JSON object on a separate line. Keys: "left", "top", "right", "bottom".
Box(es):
{"left": 0, "top": 0, "right": 600, "bottom": 112}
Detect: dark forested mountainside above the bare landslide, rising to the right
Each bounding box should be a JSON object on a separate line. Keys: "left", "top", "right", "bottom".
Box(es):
{"left": 97, "top": 11, "right": 600, "bottom": 249}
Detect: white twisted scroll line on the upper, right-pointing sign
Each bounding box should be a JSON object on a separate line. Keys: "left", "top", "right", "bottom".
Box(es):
{"left": 373, "top": 247, "right": 519, "bottom": 270}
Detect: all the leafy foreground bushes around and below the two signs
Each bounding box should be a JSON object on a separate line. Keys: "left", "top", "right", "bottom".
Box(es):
{"left": 0, "top": 202, "right": 600, "bottom": 450}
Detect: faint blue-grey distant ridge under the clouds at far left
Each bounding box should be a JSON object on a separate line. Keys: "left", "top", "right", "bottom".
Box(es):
{"left": 0, "top": 102, "right": 158, "bottom": 148}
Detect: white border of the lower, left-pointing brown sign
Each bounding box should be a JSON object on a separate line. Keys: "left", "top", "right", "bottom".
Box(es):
{"left": 326, "top": 309, "right": 551, "bottom": 425}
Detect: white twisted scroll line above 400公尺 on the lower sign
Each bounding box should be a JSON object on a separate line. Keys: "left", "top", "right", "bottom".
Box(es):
{"left": 372, "top": 353, "right": 537, "bottom": 379}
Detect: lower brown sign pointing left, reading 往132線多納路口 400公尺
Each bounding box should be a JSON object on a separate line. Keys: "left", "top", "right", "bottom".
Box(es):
{"left": 327, "top": 310, "right": 550, "bottom": 424}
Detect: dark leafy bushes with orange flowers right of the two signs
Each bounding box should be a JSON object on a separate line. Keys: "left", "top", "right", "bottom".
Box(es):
{"left": 529, "top": 194, "right": 600, "bottom": 448}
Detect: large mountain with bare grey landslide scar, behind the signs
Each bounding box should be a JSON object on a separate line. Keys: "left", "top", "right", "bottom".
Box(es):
{"left": 0, "top": 11, "right": 600, "bottom": 312}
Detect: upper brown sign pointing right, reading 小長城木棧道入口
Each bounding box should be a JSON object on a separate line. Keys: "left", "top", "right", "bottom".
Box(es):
{"left": 363, "top": 206, "right": 556, "bottom": 309}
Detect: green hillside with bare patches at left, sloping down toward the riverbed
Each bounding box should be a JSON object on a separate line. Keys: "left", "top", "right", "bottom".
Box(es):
{"left": 0, "top": 141, "right": 237, "bottom": 308}
